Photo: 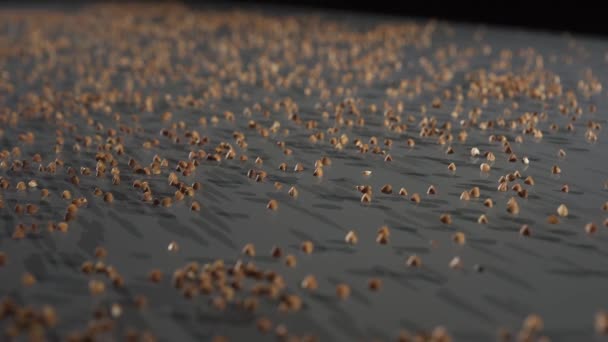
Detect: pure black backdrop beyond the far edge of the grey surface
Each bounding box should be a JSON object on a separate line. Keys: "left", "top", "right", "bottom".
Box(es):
{"left": 218, "top": 0, "right": 608, "bottom": 36}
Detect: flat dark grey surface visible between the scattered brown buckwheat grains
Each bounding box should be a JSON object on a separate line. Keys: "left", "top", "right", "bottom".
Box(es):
{"left": 0, "top": 3, "right": 608, "bottom": 341}
